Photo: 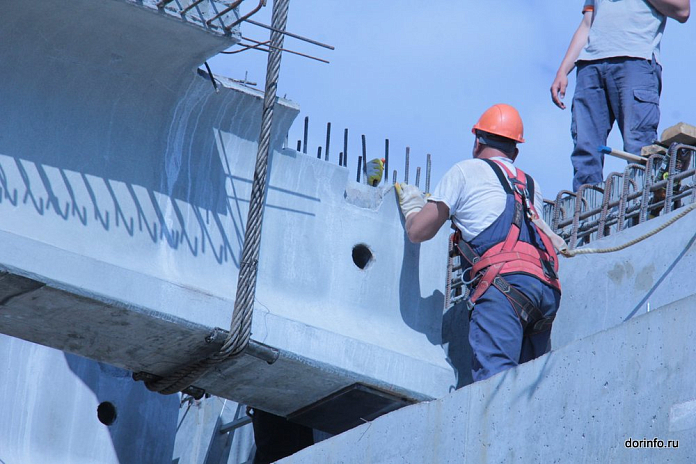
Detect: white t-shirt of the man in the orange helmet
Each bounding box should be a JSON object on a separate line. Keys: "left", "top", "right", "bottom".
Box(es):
{"left": 428, "top": 157, "right": 544, "bottom": 241}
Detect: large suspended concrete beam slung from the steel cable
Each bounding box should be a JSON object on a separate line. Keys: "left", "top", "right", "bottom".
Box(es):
{"left": 0, "top": 0, "right": 455, "bottom": 428}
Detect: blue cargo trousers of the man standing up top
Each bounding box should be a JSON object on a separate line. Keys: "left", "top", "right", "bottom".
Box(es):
{"left": 570, "top": 57, "right": 662, "bottom": 191}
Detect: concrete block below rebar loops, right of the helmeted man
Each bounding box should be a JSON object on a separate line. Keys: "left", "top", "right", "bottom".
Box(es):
{"left": 552, "top": 205, "right": 696, "bottom": 348}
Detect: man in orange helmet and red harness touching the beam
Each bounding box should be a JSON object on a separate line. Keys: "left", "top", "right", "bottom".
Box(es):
{"left": 396, "top": 104, "right": 565, "bottom": 381}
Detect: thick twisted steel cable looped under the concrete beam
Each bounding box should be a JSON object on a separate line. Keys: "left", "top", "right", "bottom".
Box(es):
{"left": 145, "top": 0, "right": 290, "bottom": 395}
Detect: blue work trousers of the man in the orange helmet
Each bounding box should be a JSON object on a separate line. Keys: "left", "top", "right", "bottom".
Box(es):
{"left": 469, "top": 274, "right": 561, "bottom": 382}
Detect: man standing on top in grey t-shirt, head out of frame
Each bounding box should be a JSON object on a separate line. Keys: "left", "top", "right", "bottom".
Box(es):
{"left": 551, "top": 0, "right": 690, "bottom": 191}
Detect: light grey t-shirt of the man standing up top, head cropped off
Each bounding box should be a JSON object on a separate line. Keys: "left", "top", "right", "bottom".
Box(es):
{"left": 578, "top": 0, "right": 667, "bottom": 63}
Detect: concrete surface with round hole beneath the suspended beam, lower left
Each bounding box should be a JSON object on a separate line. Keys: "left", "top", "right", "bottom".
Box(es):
{"left": 0, "top": 335, "right": 253, "bottom": 464}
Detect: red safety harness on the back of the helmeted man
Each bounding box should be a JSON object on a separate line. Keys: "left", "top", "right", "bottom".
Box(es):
{"left": 460, "top": 160, "right": 561, "bottom": 304}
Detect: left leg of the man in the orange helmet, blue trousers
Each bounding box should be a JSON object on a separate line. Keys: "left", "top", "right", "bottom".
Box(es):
{"left": 469, "top": 287, "right": 522, "bottom": 382}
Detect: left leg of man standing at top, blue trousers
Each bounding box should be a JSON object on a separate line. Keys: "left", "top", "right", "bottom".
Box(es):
{"left": 570, "top": 61, "right": 615, "bottom": 191}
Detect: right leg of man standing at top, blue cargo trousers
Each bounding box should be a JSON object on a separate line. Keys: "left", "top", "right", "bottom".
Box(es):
{"left": 608, "top": 58, "right": 662, "bottom": 155}
